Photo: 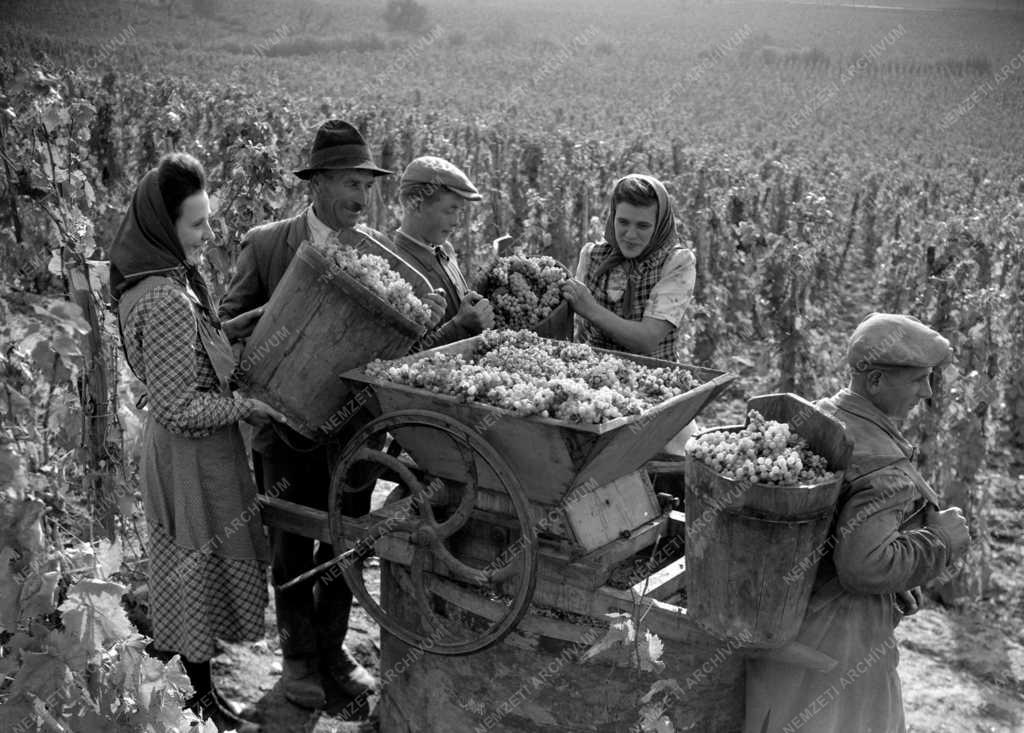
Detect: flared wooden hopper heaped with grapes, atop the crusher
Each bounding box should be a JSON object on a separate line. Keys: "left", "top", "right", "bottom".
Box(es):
{"left": 344, "top": 331, "right": 735, "bottom": 505}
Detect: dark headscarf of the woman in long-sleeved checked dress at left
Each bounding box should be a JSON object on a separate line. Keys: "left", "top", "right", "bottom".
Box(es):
{"left": 111, "top": 168, "right": 220, "bottom": 326}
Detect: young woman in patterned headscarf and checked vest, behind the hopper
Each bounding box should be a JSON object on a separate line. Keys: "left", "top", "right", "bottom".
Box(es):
{"left": 563, "top": 174, "right": 696, "bottom": 361}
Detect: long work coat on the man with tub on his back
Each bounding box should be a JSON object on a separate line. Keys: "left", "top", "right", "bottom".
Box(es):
{"left": 744, "top": 389, "right": 957, "bottom": 733}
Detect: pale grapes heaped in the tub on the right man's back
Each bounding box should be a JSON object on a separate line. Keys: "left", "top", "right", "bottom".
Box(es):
{"left": 686, "top": 409, "right": 834, "bottom": 485}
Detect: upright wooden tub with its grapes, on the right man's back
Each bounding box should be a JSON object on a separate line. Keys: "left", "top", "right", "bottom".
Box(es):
{"left": 685, "top": 394, "right": 853, "bottom": 649}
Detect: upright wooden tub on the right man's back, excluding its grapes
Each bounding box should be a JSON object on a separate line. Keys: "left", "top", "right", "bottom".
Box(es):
{"left": 685, "top": 394, "right": 852, "bottom": 648}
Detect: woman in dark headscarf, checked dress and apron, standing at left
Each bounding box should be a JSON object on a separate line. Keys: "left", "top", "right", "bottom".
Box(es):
{"left": 111, "top": 154, "right": 284, "bottom": 731}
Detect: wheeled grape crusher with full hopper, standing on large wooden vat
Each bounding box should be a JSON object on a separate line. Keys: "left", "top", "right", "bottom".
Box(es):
{"left": 264, "top": 332, "right": 828, "bottom": 733}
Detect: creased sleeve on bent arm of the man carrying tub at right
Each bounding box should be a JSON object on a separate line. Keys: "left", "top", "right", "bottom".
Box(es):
{"left": 835, "top": 474, "right": 949, "bottom": 594}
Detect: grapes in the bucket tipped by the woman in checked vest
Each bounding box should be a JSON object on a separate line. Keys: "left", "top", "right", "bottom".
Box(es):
{"left": 477, "top": 255, "right": 569, "bottom": 329}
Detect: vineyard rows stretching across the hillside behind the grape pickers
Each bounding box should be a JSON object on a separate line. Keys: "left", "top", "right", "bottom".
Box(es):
{"left": 0, "top": 0, "right": 1024, "bottom": 733}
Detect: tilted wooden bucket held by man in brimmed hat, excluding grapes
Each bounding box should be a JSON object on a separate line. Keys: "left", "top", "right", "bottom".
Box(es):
{"left": 240, "top": 242, "right": 426, "bottom": 440}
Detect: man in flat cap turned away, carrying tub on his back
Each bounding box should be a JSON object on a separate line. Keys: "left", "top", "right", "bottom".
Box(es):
{"left": 744, "top": 313, "right": 969, "bottom": 733}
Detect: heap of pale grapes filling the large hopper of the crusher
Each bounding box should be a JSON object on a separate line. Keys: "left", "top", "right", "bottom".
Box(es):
{"left": 367, "top": 330, "right": 699, "bottom": 425}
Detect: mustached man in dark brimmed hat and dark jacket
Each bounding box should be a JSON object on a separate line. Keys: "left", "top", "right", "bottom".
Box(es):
{"left": 219, "top": 120, "right": 442, "bottom": 708}
